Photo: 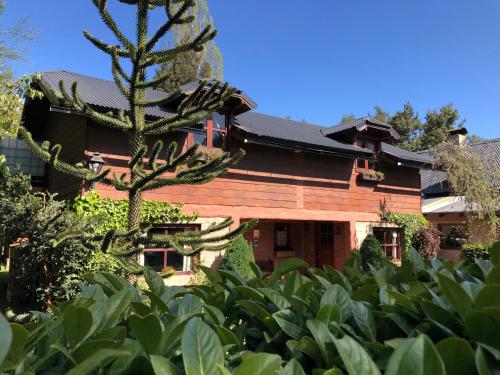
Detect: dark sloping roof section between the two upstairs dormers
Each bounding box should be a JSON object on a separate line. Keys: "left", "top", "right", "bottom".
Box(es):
{"left": 235, "top": 112, "right": 372, "bottom": 156}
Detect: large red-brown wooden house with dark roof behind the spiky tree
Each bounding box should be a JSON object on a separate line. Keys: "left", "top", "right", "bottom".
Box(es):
{"left": 24, "top": 71, "right": 430, "bottom": 284}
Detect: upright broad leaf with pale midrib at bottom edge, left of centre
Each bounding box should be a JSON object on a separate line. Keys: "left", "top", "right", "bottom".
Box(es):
{"left": 181, "top": 317, "right": 224, "bottom": 375}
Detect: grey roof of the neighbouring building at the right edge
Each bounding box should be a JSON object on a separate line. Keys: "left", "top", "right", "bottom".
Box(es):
{"left": 418, "top": 138, "right": 500, "bottom": 196}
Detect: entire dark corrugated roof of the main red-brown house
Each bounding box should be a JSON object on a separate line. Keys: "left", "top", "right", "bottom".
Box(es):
{"left": 40, "top": 71, "right": 426, "bottom": 163}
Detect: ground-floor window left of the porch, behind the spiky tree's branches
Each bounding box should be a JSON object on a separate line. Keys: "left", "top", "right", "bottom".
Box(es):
{"left": 144, "top": 225, "right": 200, "bottom": 273}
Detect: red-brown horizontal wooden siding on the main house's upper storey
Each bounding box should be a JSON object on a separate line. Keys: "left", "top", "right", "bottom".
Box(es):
{"left": 87, "top": 126, "right": 420, "bottom": 219}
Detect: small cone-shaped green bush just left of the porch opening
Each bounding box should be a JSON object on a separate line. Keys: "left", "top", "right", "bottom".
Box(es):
{"left": 220, "top": 236, "right": 255, "bottom": 279}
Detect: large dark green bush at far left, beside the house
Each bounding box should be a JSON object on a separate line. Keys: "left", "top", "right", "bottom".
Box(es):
{"left": 12, "top": 194, "right": 93, "bottom": 306}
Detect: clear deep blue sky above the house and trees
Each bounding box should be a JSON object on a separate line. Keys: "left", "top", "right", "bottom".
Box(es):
{"left": 4, "top": 0, "right": 500, "bottom": 138}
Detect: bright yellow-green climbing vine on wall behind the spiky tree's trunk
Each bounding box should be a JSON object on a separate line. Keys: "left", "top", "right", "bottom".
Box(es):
{"left": 73, "top": 191, "right": 198, "bottom": 234}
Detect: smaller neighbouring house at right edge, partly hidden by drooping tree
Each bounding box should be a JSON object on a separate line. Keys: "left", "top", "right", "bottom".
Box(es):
{"left": 419, "top": 127, "right": 500, "bottom": 260}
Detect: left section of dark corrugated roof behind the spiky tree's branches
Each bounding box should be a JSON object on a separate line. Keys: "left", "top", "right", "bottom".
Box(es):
{"left": 41, "top": 71, "right": 255, "bottom": 117}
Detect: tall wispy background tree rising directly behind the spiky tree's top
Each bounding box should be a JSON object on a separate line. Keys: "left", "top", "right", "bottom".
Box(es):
{"left": 156, "top": 0, "right": 223, "bottom": 92}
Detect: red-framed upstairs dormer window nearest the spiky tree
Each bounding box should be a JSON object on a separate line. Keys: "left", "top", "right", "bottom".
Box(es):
{"left": 190, "top": 112, "right": 227, "bottom": 148}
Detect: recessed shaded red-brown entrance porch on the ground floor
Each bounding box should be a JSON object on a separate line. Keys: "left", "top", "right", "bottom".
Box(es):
{"left": 245, "top": 219, "right": 351, "bottom": 271}
